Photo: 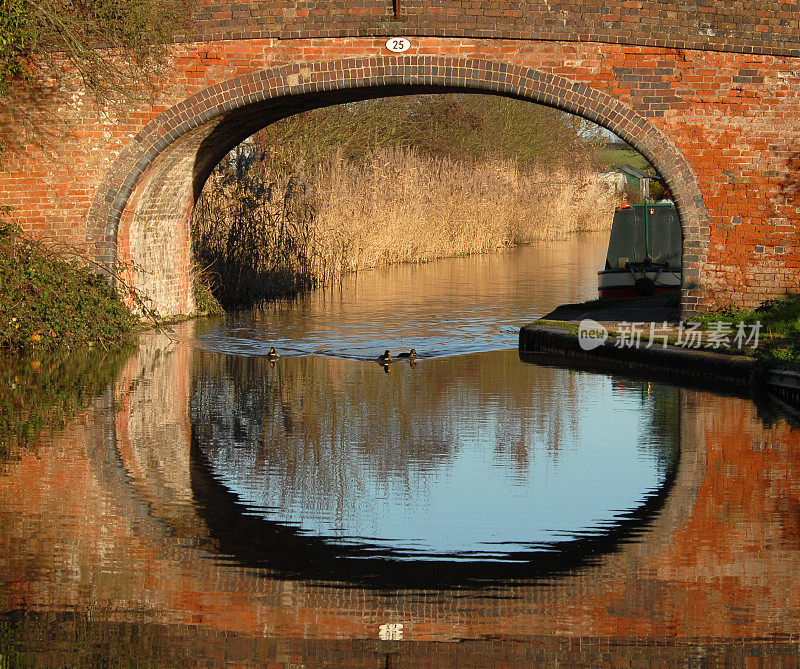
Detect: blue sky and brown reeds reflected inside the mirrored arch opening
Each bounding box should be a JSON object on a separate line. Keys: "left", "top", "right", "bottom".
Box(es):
{"left": 192, "top": 351, "right": 679, "bottom": 560}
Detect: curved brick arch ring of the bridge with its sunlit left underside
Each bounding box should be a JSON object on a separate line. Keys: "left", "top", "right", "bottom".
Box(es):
{"left": 87, "top": 56, "right": 709, "bottom": 313}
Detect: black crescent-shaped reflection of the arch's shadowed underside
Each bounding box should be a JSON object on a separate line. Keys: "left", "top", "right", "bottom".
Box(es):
{"left": 190, "top": 420, "right": 680, "bottom": 590}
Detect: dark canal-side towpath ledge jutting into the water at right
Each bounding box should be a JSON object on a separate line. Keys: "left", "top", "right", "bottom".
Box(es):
{"left": 519, "top": 295, "right": 800, "bottom": 407}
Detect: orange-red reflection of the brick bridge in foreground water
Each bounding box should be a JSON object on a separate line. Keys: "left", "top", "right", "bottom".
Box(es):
{"left": 0, "top": 328, "right": 800, "bottom": 652}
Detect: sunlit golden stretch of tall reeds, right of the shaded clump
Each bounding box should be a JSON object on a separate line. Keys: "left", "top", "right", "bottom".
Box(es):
{"left": 312, "top": 147, "right": 614, "bottom": 272}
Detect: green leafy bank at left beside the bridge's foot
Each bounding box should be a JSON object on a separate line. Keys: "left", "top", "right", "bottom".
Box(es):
{"left": 0, "top": 218, "right": 139, "bottom": 353}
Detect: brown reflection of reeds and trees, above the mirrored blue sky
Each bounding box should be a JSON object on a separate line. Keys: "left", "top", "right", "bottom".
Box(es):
{"left": 191, "top": 351, "right": 680, "bottom": 508}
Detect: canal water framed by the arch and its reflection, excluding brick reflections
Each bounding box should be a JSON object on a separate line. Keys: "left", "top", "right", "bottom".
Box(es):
{"left": 193, "top": 234, "right": 678, "bottom": 560}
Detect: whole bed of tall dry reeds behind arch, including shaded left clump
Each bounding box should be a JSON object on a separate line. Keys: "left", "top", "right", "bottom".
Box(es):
{"left": 193, "top": 147, "right": 614, "bottom": 304}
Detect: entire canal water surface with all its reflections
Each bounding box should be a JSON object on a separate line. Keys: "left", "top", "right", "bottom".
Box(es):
{"left": 0, "top": 235, "right": 800, "bottom": 667}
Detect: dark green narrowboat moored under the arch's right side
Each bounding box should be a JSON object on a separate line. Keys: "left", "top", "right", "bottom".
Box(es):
{"left": 598, "top": 202, "right": 683, "bottom": 297}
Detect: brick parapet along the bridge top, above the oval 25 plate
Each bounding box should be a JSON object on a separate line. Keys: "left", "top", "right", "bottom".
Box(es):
{"left": 185, "top": 0, "right": 800, "bottom": 56}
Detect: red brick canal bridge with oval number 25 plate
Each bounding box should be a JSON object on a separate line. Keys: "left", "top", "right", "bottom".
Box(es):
{"left": 0, "top": 0, "right": 800, "bottom": 313}
